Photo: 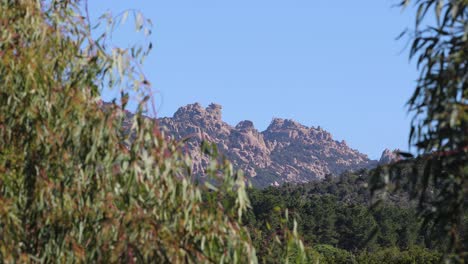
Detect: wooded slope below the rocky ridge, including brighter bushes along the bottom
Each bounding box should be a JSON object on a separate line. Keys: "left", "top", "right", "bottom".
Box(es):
{"left": 244, "top": 171, "right": 466, "bottom": 263}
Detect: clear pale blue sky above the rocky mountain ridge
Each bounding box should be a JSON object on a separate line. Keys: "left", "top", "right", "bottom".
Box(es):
{"left": 89, "top": 0, "right": 417, "bottom": 159}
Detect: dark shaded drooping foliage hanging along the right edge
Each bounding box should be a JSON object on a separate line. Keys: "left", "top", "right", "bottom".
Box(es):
{"left": 374, "top": 0, "right": 468, "bottom": 256}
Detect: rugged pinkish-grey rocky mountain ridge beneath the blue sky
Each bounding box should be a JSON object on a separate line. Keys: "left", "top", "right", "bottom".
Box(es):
{"left": 159, "top": 103, "right": 378, "bottom": 186}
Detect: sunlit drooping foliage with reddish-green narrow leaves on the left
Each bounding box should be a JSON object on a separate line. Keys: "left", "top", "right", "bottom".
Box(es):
{"left": 0, "top": 0, "right": 314, "bottom": 263}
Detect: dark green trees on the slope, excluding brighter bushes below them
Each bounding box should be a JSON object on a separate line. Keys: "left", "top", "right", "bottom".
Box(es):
{"left": 244, "top": 171, "right": 437, "bottom": 256}
